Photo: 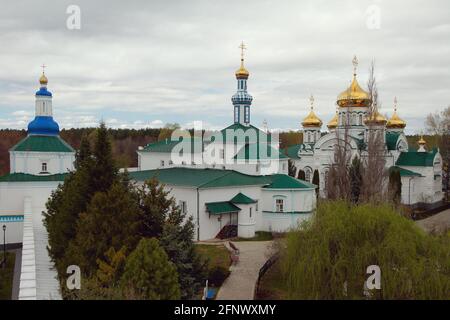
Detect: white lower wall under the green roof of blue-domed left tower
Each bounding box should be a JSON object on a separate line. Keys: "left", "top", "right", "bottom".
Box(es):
{"left": 10, "top": 151, "right": 75, "bottom": 175}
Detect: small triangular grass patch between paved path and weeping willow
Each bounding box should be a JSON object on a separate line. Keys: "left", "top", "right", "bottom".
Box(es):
{"left": 257, "top": 262, "right": 288, "bottom": 300}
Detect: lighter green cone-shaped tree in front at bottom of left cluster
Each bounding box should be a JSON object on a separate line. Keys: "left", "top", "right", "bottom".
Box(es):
{"left": 120, "top": 238, "right": 180, "bottom": 300}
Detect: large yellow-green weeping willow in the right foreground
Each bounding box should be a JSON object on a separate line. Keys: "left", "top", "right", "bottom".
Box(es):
{"left": 280, "top": 201, "right": 450, "bottom": 299}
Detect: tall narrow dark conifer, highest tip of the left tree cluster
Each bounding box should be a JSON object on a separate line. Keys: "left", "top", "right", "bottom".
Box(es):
{"left": 91, "top": 122, "right": 118, "bottom": 192}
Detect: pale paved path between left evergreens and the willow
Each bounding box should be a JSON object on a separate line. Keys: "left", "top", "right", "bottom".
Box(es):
{"left": 216, "top": 241, "right": 273, "bottom": 300}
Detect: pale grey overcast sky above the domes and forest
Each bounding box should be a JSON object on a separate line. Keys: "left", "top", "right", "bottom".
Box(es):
{"left": 0, "top": 0, "right": 450, "bottom": 133}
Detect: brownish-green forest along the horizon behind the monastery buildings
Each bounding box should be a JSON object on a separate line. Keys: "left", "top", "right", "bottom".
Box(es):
{"left": 0, "top": 128, "right": 436, "bottom": 175}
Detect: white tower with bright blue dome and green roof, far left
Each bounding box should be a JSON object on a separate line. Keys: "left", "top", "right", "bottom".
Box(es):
{"left": 9, "top": 66, "right": 75, "bottom": 175}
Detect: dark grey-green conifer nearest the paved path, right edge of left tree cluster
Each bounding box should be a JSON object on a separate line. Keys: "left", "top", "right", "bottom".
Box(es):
{"left": 160, "top": 203, "right": 206, "bottom": 299}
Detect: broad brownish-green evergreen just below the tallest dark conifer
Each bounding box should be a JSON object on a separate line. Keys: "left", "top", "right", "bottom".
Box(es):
{"left": 67, "top": 182, "right": 140, "bottom": 276}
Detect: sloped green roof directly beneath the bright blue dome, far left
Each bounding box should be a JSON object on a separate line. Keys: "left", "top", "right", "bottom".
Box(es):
{"left": 10, "top": 135, "right": 75, "bottom": 152}
